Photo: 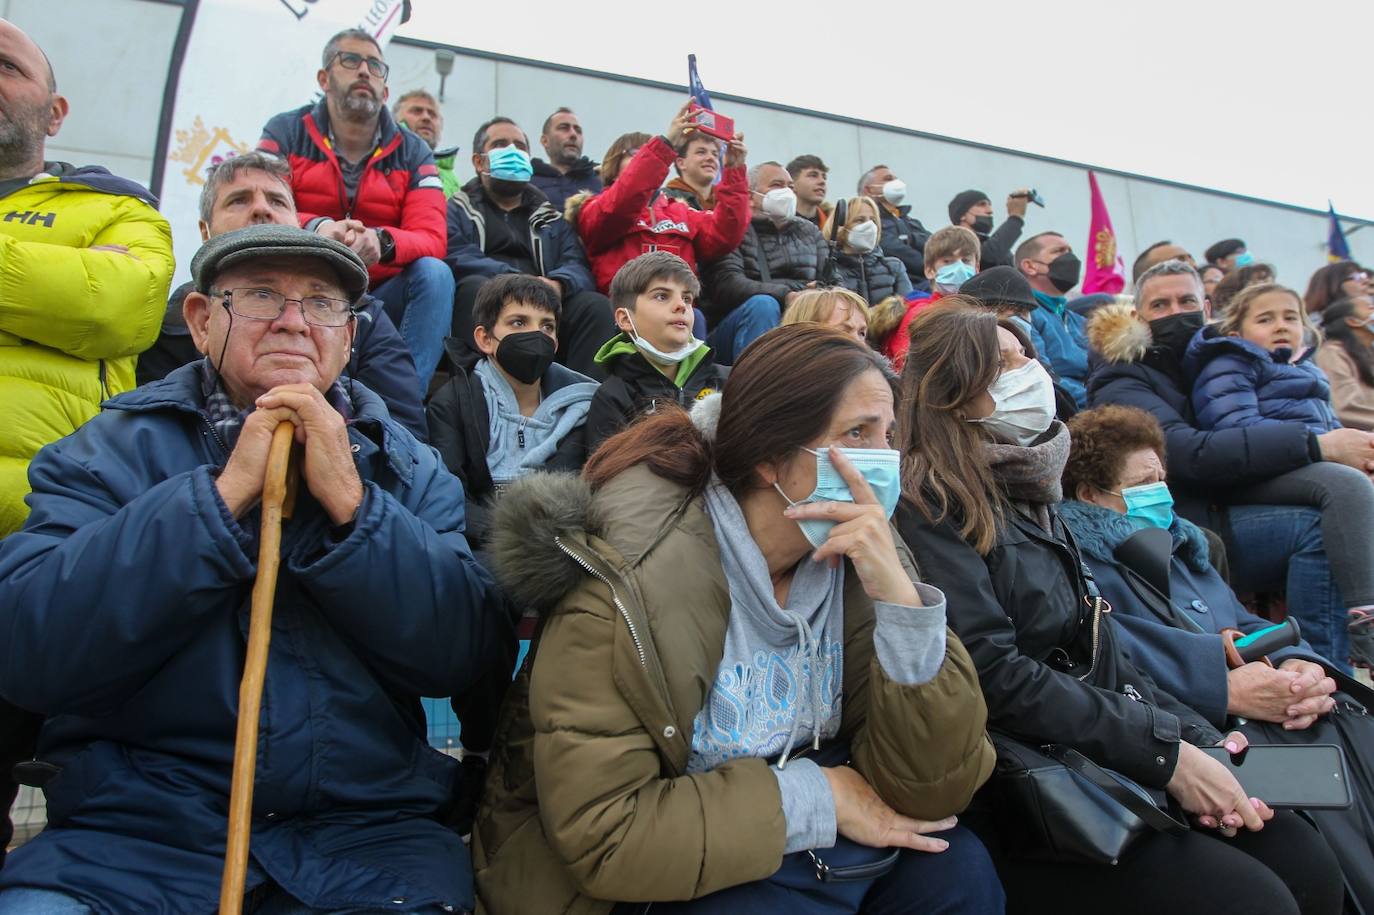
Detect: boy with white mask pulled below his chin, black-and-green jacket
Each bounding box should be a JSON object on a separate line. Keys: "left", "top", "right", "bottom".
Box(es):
{"left": 587, "top": 251, "right": 728, "bottom": 455}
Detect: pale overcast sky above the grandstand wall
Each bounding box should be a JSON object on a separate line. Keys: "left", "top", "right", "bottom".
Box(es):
{"left": 400, "top": 0, "right": 1374, "bottom": 218}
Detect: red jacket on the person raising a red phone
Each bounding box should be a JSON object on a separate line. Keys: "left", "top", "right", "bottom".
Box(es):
{"left": 577, "top": 136, "right": 749, "bottom": 293}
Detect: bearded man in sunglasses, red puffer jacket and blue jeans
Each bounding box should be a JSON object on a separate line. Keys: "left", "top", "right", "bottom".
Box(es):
{"left": 258, "top": 29, "right": 453, "bottom": 394}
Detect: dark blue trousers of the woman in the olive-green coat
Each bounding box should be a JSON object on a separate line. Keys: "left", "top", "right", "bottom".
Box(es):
{"left": 629, "top": 826, "right": 1006, "bottom": 915}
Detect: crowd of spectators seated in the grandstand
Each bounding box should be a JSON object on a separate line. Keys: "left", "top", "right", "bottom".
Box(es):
{"left": 0, "top": 21, "right": 1374, "bottom": 915}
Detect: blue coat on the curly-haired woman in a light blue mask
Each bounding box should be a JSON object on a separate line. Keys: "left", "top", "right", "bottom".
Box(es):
{"left": 1059, "top": 500, "right": 1330, "bottom": 728}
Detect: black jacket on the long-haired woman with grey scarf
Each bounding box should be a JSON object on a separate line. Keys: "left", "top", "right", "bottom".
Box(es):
{"left": 894, "top": 500, "right": 1221, "bottom": 789}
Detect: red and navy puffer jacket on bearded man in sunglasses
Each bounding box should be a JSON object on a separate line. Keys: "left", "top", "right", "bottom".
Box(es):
{"left": 258, "top": 99, "right": 448, "bottom": 289}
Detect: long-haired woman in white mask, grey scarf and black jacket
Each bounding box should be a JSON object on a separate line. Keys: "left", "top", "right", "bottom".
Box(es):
{"left": 896, "top": 308, "right": 1341, "bottom": 915}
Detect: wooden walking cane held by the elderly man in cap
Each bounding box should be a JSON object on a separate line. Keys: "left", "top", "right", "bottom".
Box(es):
{"left": 220, "top": 422, "right": 295, "bottom": 915}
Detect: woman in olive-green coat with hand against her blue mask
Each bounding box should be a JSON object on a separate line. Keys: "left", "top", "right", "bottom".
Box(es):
{"left": 473, "top": 324, "right": 1002, "bottom": 915}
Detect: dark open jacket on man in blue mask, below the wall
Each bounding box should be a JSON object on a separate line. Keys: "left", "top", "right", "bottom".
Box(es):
{"left": 444, "top": 179, "right": 596, "bottom": 300}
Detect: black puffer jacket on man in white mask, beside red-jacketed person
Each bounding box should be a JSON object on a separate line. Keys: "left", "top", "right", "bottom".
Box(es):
{"left": 703, "top": 216, "right": 829, "bottom": 323}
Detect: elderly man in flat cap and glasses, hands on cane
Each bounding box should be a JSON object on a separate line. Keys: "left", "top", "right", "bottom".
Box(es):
{"left": 0, "top": 225, "right": 508, "bottom": 915}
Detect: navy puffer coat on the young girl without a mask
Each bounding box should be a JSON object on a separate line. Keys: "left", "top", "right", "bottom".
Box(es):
{"left": 1183, "top": 327, "right": 1341, "bottom": 436}
